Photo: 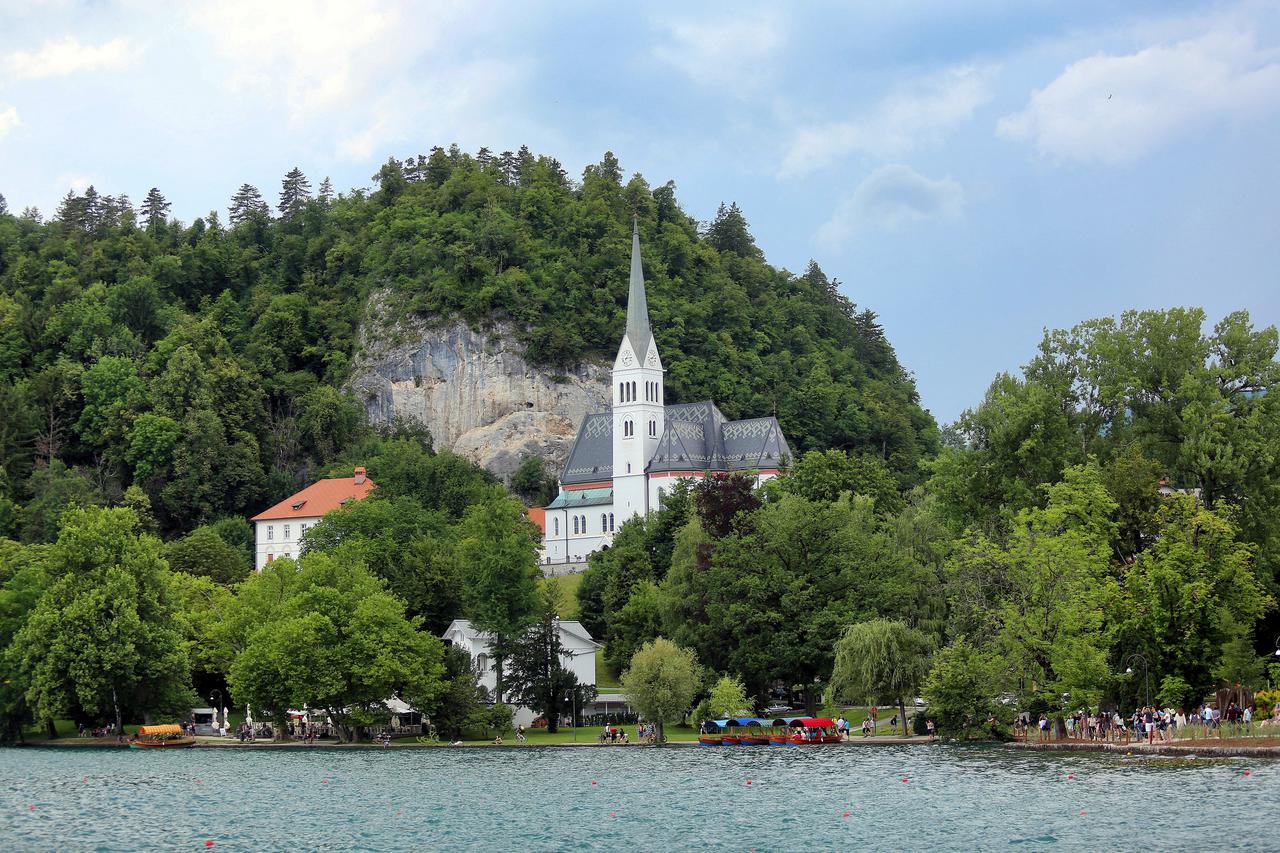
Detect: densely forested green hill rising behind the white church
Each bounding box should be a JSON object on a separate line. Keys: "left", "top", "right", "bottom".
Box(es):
{"left": 0, "top": 147, "right": 937, "bottom": 542}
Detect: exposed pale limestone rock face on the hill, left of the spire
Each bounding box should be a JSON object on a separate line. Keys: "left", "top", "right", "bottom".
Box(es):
{"left": 349, "top": 297, "right": 609, "bottom": 478}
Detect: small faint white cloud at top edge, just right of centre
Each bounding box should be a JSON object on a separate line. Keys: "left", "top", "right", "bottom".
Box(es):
{"left": 653, "top": 12, "right": 786, "bottom": 96}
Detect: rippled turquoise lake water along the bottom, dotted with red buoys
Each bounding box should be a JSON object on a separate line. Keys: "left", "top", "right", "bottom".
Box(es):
{"left": 0, "top": 745, "right": 1280, "bottom": 853}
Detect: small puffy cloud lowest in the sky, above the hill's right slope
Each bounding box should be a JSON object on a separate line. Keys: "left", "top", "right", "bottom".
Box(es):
{"left": 817, "top": 164, "right": 964, "bottom": 248}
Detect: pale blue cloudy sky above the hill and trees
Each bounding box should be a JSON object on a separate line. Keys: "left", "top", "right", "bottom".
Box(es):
{"left": 0, "top": 0, "right": 1280, "bottom": 421}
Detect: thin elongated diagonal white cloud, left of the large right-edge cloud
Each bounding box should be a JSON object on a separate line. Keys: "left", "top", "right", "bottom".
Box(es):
{"left": 778, "top": 65, "right": 996, "bottom": 177}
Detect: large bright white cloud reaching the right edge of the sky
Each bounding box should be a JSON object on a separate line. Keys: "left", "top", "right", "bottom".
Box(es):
{"left": 996, "top": 31, "right": 1280, "bottom": 164}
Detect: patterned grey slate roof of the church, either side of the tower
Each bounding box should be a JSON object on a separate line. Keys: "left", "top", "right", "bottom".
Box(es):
{"left": 561, "top": 400, "right": 791, "bottom": 485}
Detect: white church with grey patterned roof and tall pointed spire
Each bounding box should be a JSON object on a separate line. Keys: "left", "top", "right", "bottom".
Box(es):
{"left": 530, "top": 219, "right": 791, "bottom": 571}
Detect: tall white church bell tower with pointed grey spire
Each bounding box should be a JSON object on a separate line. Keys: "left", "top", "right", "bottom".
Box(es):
{"left": 613, "top": 219, "right": 664, "bottom": 514}
